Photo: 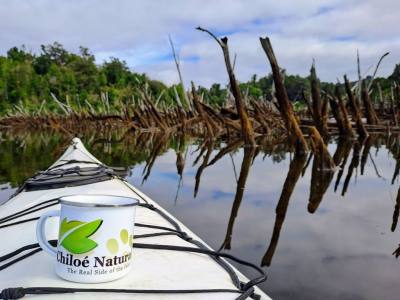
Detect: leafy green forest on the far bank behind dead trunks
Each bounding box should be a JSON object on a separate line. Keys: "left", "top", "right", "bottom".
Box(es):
{"left": 0, "top": 42, "right": 400, "bottom": 116}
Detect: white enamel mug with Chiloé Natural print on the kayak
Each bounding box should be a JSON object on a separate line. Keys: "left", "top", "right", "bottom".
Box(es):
{"left": 36, "top": 195, "right": 139, "bottom": 283}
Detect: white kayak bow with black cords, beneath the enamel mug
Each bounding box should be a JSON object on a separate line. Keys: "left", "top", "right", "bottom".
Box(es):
{"left": 0, "top": 138, "right": 270, "bottom": 300}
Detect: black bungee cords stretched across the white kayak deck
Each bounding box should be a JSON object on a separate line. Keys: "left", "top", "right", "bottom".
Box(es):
{"left": 0, "top": 160, "right": 267, "bottom": 300}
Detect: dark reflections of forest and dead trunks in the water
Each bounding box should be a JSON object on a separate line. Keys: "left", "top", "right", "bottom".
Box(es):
{"left": 6, "top": 129, "right": 400, "bottom": 266}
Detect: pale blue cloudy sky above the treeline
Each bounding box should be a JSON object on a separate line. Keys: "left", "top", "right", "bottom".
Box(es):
{"left": 0, "top": 0, "right": 400, "bottom": 86}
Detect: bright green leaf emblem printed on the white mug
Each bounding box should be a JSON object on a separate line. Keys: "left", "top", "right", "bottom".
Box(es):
{"left": 59, "top": 218, "right": 103, "bottom": 254}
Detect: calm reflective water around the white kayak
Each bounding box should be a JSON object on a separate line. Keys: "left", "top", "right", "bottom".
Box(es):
{"left": 0, "top": 133, "right": 400, "bottom": 299}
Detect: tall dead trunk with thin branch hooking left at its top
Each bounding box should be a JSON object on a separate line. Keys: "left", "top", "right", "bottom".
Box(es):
{"left": 196, "top": 27, "right": 256, "bottom": 146}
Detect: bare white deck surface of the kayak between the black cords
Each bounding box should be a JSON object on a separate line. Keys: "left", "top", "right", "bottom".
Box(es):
{"left": 0, "top": 139, "right": 270, "bottom": 299}
